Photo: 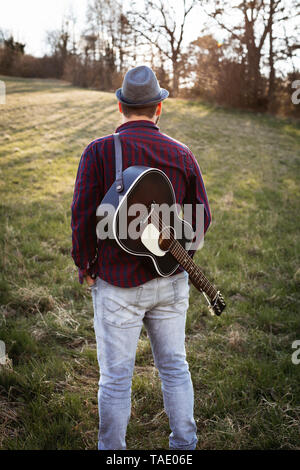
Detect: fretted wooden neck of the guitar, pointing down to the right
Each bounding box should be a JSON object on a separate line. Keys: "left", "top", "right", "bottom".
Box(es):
{"left": 169, "top": 240, "right": 218, "bottom": 301}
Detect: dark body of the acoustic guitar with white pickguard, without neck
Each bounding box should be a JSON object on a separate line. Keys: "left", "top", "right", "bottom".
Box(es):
{"left": 97, "top": 166, "right": 194, "bottom": 277}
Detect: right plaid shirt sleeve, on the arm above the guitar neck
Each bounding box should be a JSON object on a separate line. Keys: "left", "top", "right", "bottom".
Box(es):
{"left": 184, "top": 151, "right": 211, "bottom": 256}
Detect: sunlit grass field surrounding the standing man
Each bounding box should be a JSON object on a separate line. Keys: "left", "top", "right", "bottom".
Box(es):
{"left": 0, "top": 77, "right": 300, "bottom": 449}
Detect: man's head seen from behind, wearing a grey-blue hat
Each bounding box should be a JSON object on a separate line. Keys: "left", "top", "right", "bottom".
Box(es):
{"left": 116, "top": 65, "right": 169, "bottom": 122}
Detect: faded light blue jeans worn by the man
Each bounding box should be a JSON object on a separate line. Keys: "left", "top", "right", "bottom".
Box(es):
{"left": 91, "top": 271, "right": 197, "bottom": 450}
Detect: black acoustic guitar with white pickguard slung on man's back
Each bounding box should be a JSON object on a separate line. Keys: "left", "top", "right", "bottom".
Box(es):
{"left": 96, "top": 166, "right": 226, "bottom": 315}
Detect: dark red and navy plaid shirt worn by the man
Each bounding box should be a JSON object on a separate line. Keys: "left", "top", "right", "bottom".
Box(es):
{"left": 72, "top": 120, "right": 210, "bottom": 287}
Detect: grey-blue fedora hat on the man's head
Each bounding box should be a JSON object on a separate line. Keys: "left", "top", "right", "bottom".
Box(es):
{"left": 116, "top": 65, "right": 169, "bottom": 107}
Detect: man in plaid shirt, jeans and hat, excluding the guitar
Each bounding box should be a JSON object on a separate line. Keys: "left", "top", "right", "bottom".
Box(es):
{"left": 71, "top": 66, "right": 211, "bottom": 450}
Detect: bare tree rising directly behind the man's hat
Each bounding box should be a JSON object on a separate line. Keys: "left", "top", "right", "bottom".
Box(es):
{"left": 127, "top": 0, "right": 199, "bottom": 96}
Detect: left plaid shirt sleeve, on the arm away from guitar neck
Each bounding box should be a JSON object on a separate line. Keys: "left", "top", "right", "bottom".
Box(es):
{"left": 71, "top": 146, "right": 102, "bottom": 284}
